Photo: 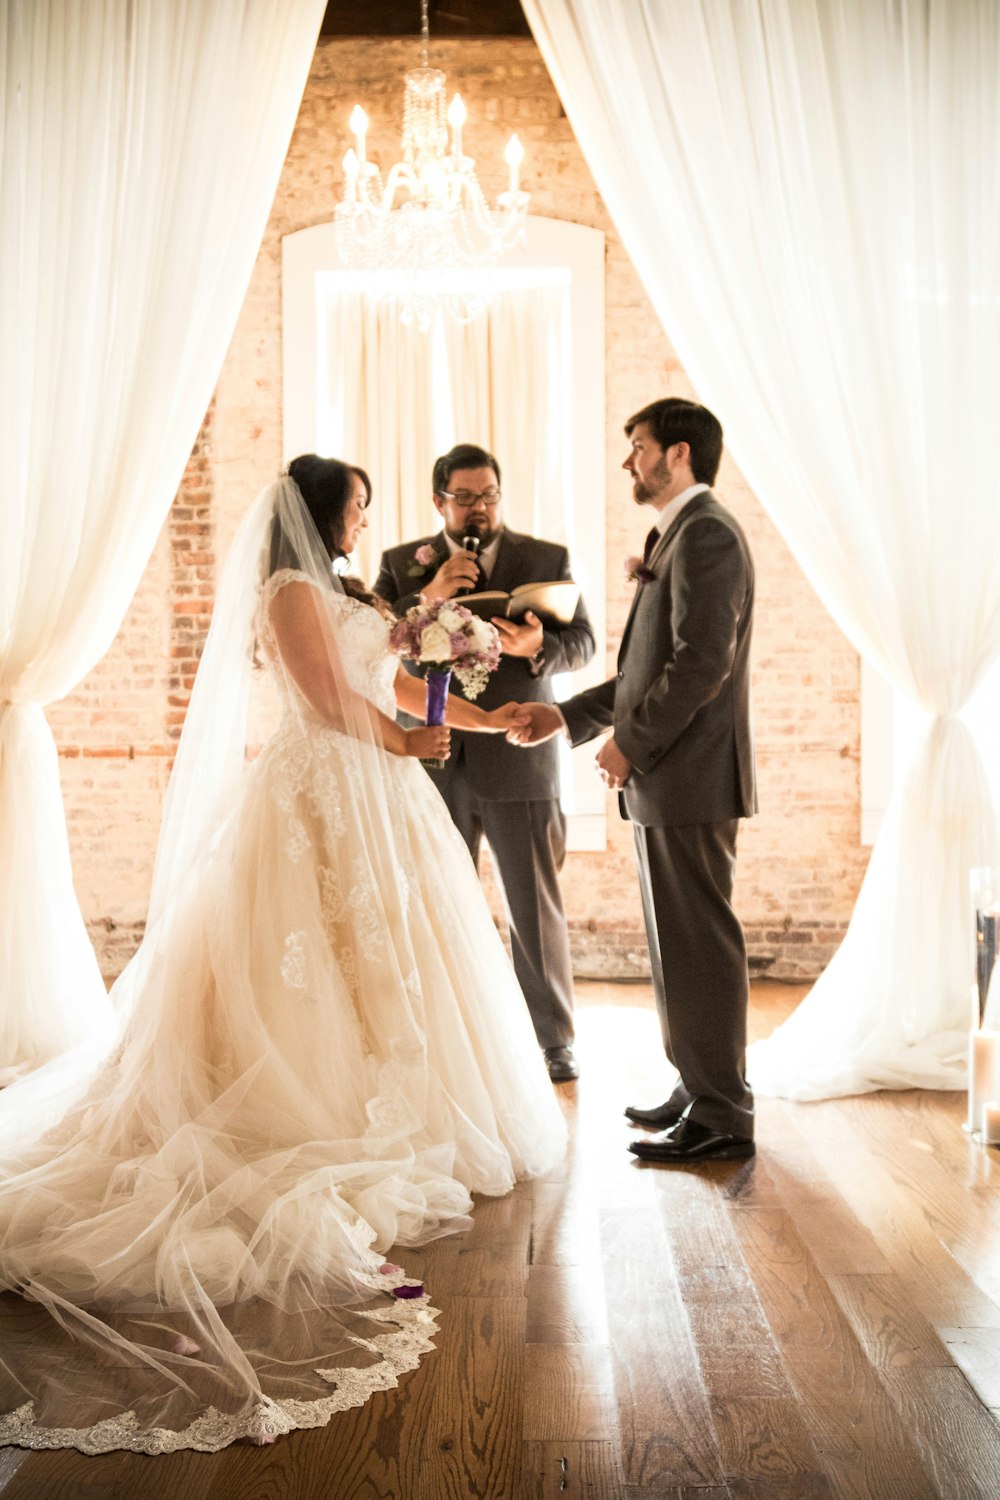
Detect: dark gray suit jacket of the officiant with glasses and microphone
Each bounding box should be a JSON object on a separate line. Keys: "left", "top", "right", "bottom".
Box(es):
{"left": 375, "top": 527, "right": 594, "bottom": 803}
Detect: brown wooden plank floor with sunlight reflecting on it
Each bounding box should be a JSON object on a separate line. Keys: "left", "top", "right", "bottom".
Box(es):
{"left": 0, "top": 983, "right": 1000, "bottom": 1500}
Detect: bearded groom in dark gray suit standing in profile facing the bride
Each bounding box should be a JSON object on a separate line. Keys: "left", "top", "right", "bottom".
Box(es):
{"left": 511, "top": 399, "right": 757, "bottom": 1166}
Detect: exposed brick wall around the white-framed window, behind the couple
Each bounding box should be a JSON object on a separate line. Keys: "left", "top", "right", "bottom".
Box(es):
{"left": 52, "top": 38, "right": 867, "bottom": 978}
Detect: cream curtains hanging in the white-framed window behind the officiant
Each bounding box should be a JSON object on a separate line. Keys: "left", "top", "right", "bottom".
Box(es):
{"left": 319, "top": 282, "right": 569, "bottom": 582}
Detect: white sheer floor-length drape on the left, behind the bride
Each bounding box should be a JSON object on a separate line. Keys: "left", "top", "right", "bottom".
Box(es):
{"left": 0, "top": 0, "right": 324, "bottom": 1076}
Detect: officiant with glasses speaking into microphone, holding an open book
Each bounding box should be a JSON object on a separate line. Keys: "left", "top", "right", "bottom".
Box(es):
{"left": 375, "top": 443, "right": 594, "bottom": 1083}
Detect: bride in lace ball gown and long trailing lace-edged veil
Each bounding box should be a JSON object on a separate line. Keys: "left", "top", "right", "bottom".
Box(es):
{"left": 0, "top": 455, "right": 565, "bottom": 1454}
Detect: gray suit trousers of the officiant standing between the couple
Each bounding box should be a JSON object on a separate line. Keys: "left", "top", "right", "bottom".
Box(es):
{"left": 444, "top": 764, "right": 573, "bottom": 1047}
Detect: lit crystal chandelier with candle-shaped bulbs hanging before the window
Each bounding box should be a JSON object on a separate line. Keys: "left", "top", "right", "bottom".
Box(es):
{"left": 334, "top": 0, "right": 529, "bottom": 323}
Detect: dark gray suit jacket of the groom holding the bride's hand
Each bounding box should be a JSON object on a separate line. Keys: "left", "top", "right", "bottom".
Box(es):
{"left": 561, "top": 491, "right": 757, "bottom": 828}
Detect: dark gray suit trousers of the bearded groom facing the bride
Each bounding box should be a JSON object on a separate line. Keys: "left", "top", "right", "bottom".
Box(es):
{"left": 633, "top": 819, "right": 754, "bottom": 1139}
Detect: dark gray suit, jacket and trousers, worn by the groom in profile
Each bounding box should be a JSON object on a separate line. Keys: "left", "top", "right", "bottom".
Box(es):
{"left": 561, "top": 491, "right": 757, "bottom": 1139}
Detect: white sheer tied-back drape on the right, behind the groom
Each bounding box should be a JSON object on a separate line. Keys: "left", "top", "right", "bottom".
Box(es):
{"left": 525, "top": 0, "right": 1000, "bottom": 1098}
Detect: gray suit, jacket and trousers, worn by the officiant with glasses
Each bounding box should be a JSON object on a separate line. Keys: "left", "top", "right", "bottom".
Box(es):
{"left": 375, "top": 527, "right": 594, "bottom": 1047}
